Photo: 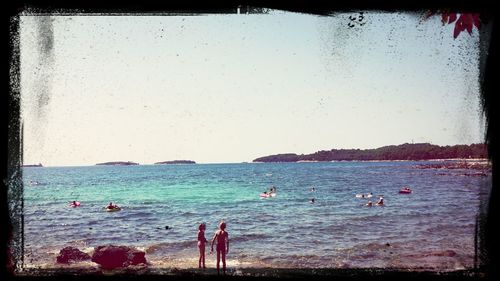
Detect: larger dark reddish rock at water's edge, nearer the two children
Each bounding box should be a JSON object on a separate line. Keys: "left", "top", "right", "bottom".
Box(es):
{"left": 92, "top": 245, "right": 147, "bottom": 269}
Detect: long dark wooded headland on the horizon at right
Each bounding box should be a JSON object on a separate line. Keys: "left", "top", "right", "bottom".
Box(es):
{"left": 253, "top": 143, "right": 488, "bottom": 162}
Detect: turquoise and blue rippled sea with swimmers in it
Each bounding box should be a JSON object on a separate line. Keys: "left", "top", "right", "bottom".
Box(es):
{"left": 22, "top": 161, "right": 491, "bottom": 270}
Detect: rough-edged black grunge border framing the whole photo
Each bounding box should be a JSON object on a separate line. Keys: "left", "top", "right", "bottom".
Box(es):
{"left": 0, "top": 0, "right": 499, "bottom": 280}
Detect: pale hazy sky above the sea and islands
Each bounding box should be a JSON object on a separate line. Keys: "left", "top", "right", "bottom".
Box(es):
{"left": 19, "top": 10, "right": 485, "bottom": 166}
